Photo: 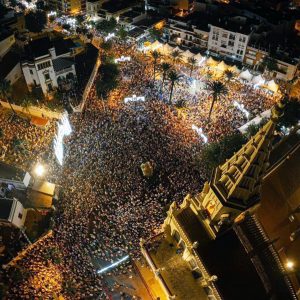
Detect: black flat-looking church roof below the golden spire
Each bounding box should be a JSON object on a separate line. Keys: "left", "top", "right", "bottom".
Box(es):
{"left": 177, "top": 208, "right": 269, "bottom": 300}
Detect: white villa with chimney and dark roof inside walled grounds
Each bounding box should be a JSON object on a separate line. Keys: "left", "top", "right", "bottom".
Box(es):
{"left": 21, "top": 37, "right": 76, "bottom": 96}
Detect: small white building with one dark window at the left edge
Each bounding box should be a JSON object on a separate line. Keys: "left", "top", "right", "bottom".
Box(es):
{"left": 0, "top": 198, "right": 27, "bottom": 228}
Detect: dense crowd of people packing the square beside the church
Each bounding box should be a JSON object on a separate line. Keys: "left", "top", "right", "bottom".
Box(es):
{"left": 1, "top": 38, "right": 280, "bottom": 299}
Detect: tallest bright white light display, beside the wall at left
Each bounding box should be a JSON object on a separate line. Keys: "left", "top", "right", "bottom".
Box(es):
{"left": 54, "top": 113, "right": 72, "bottom": 165}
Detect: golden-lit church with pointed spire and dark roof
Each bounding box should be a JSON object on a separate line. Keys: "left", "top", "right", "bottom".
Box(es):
{"left": 141, "top": 104, "right": 297, "bottom": 300}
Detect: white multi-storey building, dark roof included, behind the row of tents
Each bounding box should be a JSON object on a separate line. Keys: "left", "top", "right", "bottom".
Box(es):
{"left": 207, "top": 17, "right": 253, "bottom": 61}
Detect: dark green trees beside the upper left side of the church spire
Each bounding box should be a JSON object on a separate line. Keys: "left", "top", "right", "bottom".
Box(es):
{"left": 198, "top": 133, "right": 247, "bottom": 177}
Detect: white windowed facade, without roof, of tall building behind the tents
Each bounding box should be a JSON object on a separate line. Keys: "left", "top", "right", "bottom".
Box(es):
{"left": 208, "top": 25, "right": 249, "bottom": 61}
